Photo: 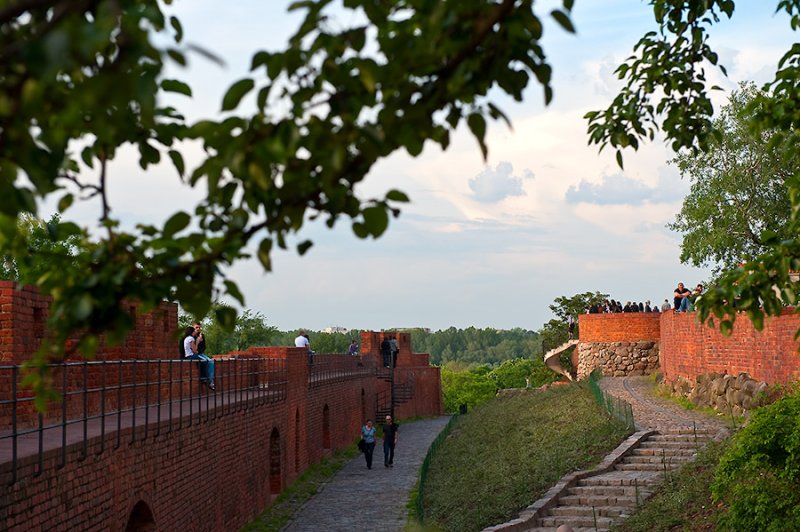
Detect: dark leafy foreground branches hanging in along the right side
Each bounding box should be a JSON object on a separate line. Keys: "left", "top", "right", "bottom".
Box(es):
{"left": 586, "top": 0, "right": 800, "bottom": 332}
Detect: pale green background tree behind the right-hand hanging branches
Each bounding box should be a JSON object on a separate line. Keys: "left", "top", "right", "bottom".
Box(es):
{"left": 669, "top": 83, "right": 800, "bottom": 274}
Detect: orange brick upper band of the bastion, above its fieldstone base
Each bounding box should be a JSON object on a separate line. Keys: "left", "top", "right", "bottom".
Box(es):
{"left": 578, "top": 312, "right": 661, "bottom": 342}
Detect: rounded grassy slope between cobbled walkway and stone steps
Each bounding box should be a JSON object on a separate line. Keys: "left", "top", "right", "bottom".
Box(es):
{"left": 424, "top": 383, "right": 627, "bottom": 531}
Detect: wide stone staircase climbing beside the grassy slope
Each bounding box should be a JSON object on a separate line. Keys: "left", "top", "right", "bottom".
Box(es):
{"left": 485, "top": 427, "right": 713, "bottom": 532}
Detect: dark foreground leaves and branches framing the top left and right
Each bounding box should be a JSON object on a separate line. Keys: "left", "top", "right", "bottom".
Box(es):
{"left": 0, "top": 0, "right": 800, "bottom": 390}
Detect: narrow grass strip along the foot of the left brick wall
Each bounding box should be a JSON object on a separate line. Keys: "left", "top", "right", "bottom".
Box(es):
{"left": 242, "top": 445, "right": 359, "bottom": 532}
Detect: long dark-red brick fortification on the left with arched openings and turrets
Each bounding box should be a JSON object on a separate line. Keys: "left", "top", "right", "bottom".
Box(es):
{"left": 0, "top": 282, "right": 443, "bottom": 531}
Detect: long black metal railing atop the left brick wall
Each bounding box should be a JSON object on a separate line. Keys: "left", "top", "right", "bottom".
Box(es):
{"left": 0, "top": 358, "right": 288, "bottom": 485}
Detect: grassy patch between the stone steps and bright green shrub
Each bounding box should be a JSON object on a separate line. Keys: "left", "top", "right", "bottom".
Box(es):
{"left": 613, "top": 441, "right": 728, "bottom": 532}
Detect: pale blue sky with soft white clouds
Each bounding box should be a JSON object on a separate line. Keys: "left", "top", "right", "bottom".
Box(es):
{"left": 45, "top": 0, "right": 797, "bottom": 330}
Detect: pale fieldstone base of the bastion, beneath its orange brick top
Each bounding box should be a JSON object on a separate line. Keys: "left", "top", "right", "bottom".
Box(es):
{"left": 577, "top": 340, "right": 659, "bottom": 379}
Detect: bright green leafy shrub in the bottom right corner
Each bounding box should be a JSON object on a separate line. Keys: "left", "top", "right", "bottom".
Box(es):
{"left": 712, "top": 392, "right": 800, "bottom": 531}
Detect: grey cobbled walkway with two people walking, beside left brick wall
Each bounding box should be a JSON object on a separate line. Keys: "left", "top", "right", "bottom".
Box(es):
{"left": 283, "top": 416, "right": 450, "bottom": 532}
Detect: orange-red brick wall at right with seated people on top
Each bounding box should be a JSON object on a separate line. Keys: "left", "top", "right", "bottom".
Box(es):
{"left": 660, "top": 309, "right": 800, "bottom": 384}
